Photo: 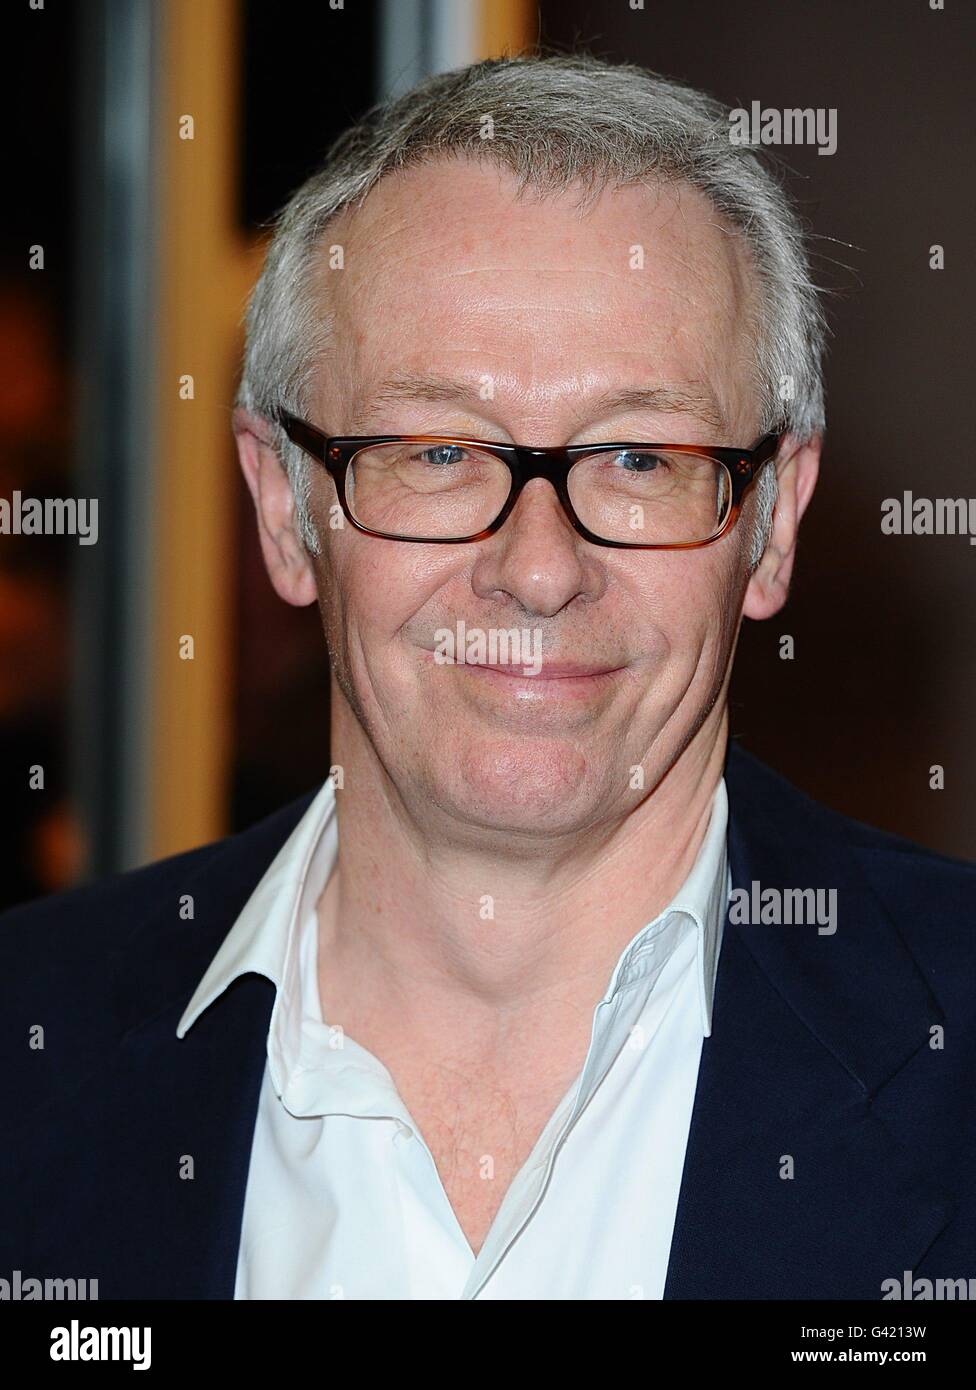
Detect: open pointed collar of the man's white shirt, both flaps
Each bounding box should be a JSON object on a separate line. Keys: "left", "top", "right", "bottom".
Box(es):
{"left": 177, "top": 777, "right": 730, "bottom": 1067}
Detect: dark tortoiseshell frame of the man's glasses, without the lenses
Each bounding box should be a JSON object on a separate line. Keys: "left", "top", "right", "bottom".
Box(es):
{"left": 275, "top": 410, "right": 781, "bottom": 550}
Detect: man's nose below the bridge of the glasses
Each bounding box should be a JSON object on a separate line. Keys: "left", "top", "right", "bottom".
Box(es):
{"left": 471, "top": 477, "right": 606, "bottom": 617}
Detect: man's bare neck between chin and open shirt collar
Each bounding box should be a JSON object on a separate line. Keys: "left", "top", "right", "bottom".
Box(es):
{"left": 318, "top": 688, "right": 729, "bottom": 1038}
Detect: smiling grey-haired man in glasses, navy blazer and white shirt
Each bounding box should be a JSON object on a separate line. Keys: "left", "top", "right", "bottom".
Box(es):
{"left": 0, "top": 58, "right": 976, "bottom": 1300}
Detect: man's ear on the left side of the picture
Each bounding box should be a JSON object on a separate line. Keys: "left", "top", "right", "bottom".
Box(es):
{"left": 234, "top": 409, "right": 316, "bottom": 607}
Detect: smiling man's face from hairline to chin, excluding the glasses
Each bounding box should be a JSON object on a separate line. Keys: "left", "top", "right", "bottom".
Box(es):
{"left": 309, "top": 161, "right": 758, "bottom": 835}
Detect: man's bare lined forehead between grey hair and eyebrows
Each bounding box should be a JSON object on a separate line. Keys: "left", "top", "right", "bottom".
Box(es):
{"left": 318, "top": 160, "right": 754, "bottom": 418}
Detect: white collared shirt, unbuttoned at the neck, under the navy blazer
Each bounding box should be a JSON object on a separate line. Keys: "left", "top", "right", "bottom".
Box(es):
{"left": 177, "top": 778, "right": 731, "bottom": 1300}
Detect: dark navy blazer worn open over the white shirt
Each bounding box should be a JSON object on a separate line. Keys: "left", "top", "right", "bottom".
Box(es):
{"left": 0, "top": 744, "right": 976, "bottom": 1300}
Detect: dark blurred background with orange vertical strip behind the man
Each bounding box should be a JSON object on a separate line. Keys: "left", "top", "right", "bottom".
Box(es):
{"left": 0, "top": 0, "right": 976, "bottom": 906}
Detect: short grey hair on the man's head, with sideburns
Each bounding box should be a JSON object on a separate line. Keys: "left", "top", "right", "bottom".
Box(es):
{"left": 236, "top": 56, "right": 827, "bottom": 567}
